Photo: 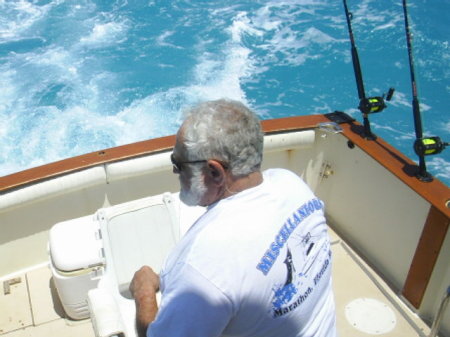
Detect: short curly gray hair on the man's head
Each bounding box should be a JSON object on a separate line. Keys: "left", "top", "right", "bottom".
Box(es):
{"left": 183, "top": 99, "right": 264, "bottom": 176}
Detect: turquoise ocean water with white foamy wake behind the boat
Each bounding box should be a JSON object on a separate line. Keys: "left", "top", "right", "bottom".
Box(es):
{"left": 0, "top": 0, "right": 450, "bottom": 185}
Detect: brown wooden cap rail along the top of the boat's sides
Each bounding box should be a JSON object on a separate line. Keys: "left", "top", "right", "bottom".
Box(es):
{"left": 0, "top": 112, "right": 450, "bottom": 218}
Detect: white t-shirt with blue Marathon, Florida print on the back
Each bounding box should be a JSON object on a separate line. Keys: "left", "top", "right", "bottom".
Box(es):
{"left": 147, "top": 169, "right": 336, "bottom": 337}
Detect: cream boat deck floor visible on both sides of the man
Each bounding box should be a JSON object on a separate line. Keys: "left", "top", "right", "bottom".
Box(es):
{"left": 0, "top": 226, "right": 429, "bottom": 337}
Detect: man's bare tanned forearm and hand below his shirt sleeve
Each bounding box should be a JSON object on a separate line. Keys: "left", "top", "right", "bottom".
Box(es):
{"left": 130, "top": 266, "right": 159, "bottom": 337}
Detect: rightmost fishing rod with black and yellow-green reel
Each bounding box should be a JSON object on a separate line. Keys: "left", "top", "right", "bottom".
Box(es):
{"left": 403, "top": 0, "right": 449, "bottom": 182}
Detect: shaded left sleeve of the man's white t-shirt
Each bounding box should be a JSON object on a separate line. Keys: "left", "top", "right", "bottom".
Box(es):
{"left": 147, "top": 265, "right": 233, "bottom": 337}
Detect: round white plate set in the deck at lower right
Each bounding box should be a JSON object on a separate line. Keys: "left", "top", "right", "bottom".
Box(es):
{"left": 345, "top": 298, "right": 397, "bottom": 335}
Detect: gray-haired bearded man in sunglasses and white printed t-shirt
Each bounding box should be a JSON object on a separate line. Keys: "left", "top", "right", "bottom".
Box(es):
{"left": 131, "top": 100, "right": 336, "bottom": 337}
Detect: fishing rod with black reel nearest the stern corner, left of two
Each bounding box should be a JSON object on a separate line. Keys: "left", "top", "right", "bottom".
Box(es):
{"left": 344, "top": 0, "right": 394, "bottom": 140}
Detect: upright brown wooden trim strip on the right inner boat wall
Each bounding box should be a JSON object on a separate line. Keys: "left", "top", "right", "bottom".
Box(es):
{"left": 402, "top": 207, "right": 450, "bottom": 309}
